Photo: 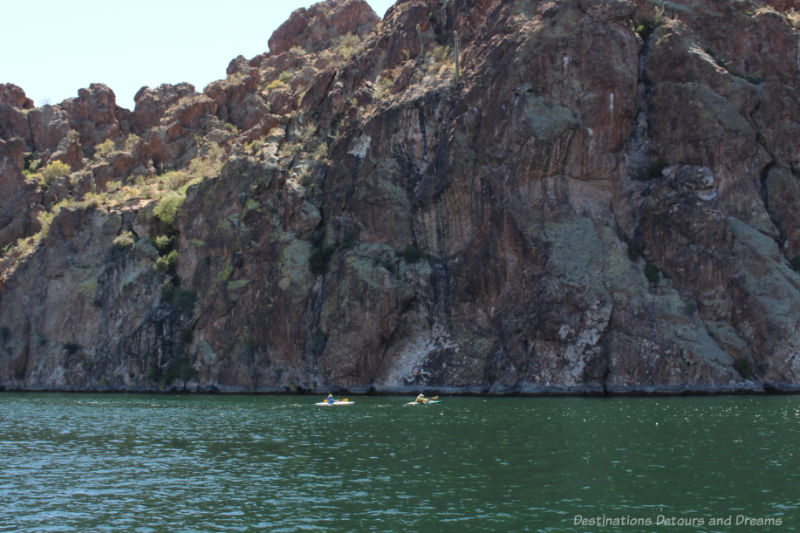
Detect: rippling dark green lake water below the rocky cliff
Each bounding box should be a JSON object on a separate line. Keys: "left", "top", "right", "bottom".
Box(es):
{"left": 0, "top": 393, "right": 800, "bottom": 532}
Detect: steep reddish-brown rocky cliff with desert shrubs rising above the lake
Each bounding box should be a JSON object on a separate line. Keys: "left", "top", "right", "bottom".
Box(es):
{"left": 0, "top": 0, "right": 800, "bottom": 394}
